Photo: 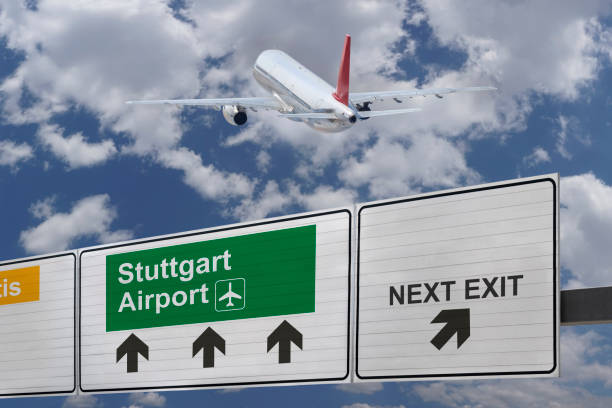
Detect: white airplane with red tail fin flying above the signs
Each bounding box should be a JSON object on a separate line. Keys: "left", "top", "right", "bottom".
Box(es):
{"left": 126, "top": 34, "right": 496, "bottom": 132}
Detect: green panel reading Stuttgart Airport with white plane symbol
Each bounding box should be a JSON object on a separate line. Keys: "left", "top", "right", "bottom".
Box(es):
{"left": 106, "top": 225, "right": 316, "bottom": 331}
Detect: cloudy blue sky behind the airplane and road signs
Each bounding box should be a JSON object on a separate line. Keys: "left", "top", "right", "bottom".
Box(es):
{"left": 0, "top": 0, "right": 612, "bottom": 408}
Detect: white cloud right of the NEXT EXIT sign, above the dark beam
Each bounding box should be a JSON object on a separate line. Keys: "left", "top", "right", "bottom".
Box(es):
{"left": 560, "top": 173, "right": 612, "bottom": 287}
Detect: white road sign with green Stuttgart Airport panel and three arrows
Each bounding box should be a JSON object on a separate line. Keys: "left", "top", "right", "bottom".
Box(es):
{"left": 79, "top": 210, "right": 351, "bottom": 392}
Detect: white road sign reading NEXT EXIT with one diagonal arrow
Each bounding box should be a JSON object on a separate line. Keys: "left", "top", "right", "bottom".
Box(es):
{"left": 355, "top": 175, "right": 559, "bottom": 381}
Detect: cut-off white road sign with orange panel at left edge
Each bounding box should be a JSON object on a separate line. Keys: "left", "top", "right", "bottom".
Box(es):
{"left": 0, "top": 253, "right": 76, "bottom": 397}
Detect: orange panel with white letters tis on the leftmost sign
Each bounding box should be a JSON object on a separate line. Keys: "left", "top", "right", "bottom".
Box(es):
{"left": 0, "top": 266, "right": 40, "bottom": 305}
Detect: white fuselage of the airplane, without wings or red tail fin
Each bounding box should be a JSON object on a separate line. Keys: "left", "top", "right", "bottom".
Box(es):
{"left": 253, "top": 50, "right": 357, "bottom": 132}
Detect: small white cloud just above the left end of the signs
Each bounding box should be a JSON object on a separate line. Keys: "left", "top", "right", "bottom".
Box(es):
{"left": 19, "top": 194, "right": 132, "bottom": 253}
